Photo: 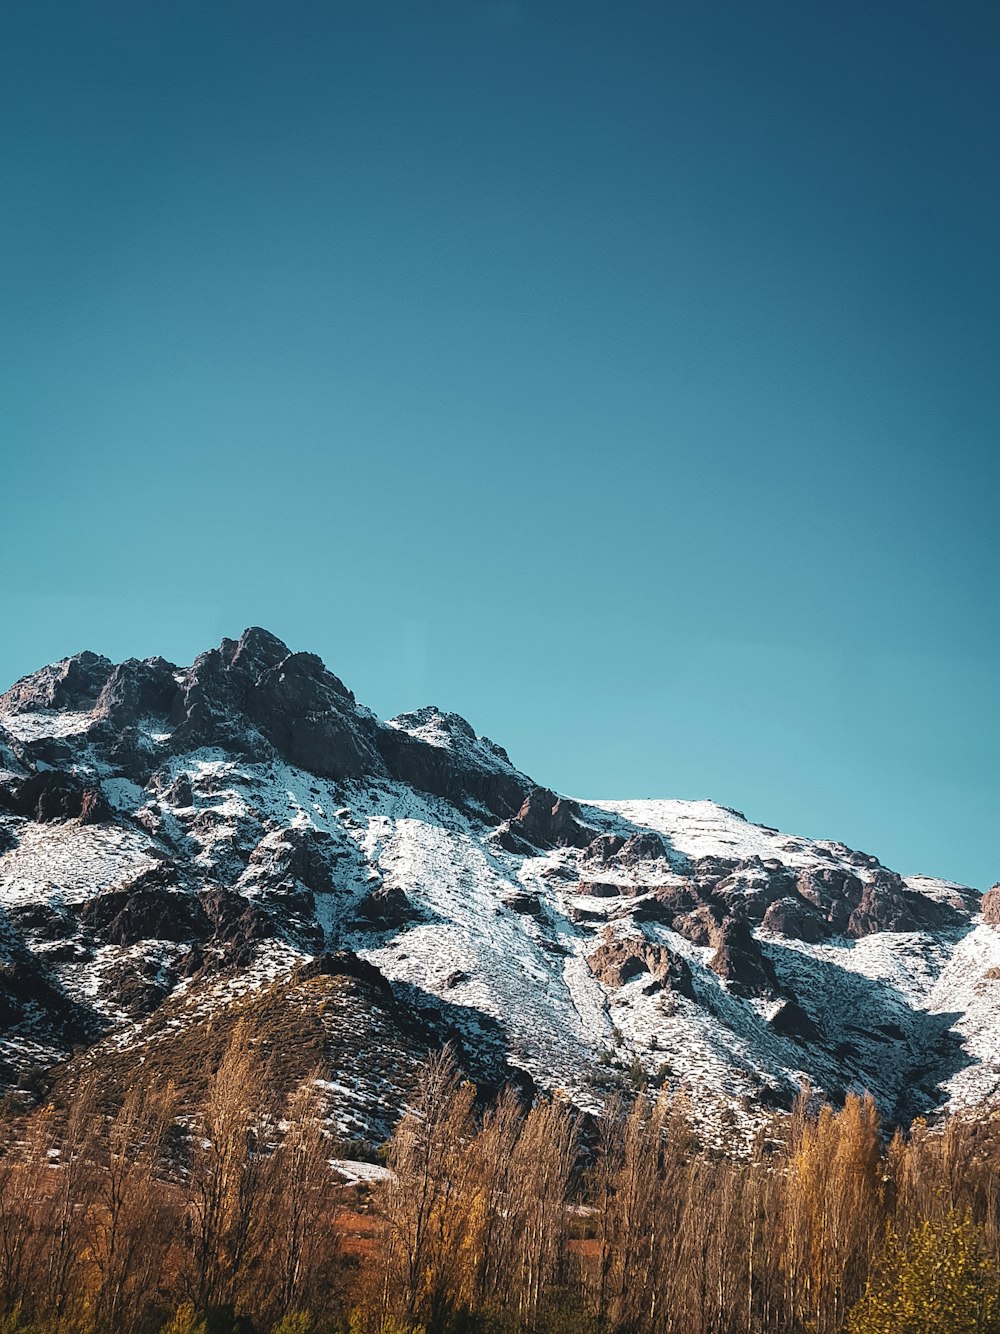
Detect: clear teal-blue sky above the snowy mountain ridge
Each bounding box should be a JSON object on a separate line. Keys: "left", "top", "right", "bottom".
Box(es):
{"left": 0, "top": 0, "right": 1000, "bottom": 887}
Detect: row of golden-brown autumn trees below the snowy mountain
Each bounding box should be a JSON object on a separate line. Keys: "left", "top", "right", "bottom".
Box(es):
{"left": 0, "top": 1026, "right": 1000, "bottom": 1334}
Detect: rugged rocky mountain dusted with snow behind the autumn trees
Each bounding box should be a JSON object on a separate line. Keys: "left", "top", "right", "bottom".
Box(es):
{"left": 0, "top": 628, "right": 1000, "bottom": 1139}
